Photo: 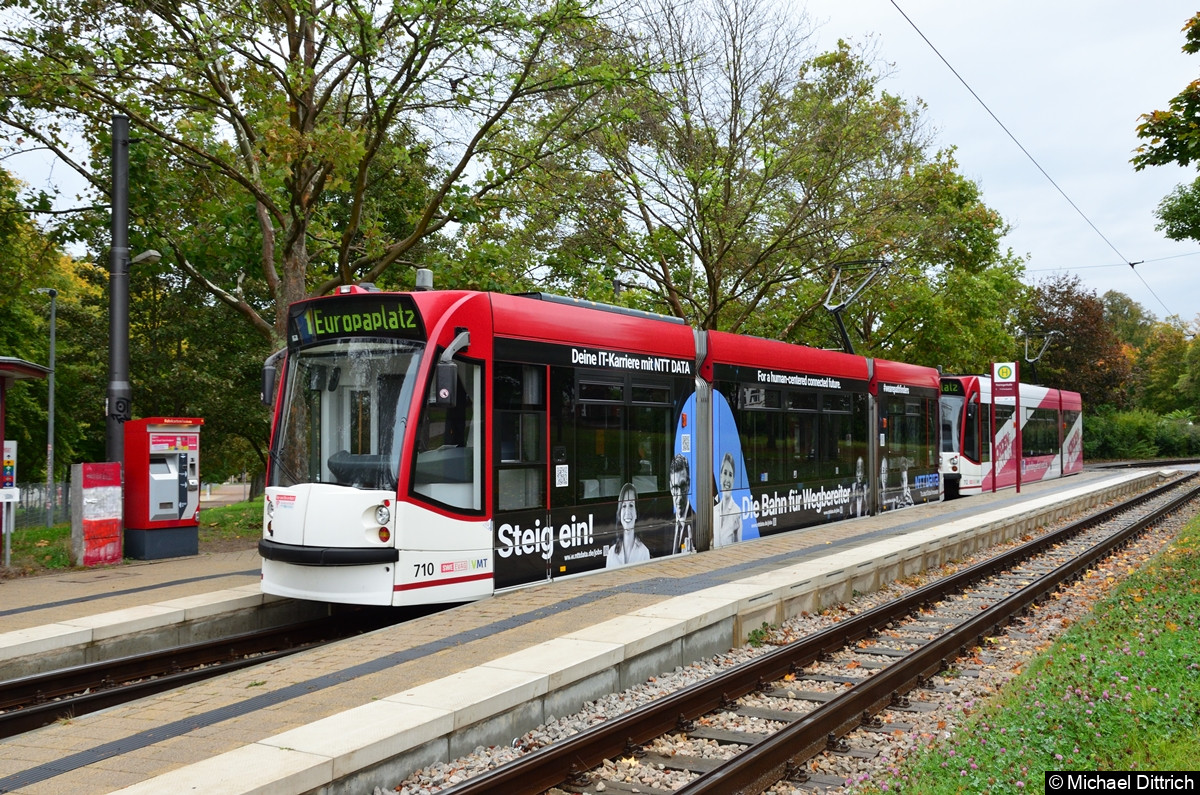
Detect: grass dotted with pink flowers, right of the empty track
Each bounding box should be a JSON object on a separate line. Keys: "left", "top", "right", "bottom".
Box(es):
{"left": 857, "top": 519, "right": 1200, "bottom": 795}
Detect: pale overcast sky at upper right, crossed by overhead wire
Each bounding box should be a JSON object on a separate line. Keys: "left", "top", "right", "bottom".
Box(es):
{"left": 806, "top": 0, "right": 1200, "bottom": 322}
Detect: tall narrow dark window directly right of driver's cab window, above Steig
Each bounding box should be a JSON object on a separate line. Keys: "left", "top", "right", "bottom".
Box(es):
{"left": 492, "top": 361, "right": 546, "bottom": 510}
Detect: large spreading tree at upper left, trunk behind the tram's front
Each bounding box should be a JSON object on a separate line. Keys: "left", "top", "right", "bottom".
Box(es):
{"left": 0, "top": 0, "right": 637, "bottom": 343}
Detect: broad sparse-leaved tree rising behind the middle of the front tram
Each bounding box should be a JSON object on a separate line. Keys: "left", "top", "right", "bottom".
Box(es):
{"left": 472, "top": 0, "right": 1018, "bottom": 369}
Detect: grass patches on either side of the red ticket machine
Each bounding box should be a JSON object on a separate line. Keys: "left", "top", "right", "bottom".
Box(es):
{"left": 0, "top": 497, "right": 263, "bottom": 576}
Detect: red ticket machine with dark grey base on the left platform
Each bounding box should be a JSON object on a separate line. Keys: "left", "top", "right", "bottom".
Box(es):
{"left": 125, "top": 417, "right": 204, "bottom": 561}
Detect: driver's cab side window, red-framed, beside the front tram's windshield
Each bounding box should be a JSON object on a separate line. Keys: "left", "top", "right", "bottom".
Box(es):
{"left": 413, "top": 360, "right": 484, "bottom": 510}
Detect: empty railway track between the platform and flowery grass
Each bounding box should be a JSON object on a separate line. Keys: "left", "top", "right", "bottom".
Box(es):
{"left": 427, "top": 476, "right": 1200, "bottom": 795}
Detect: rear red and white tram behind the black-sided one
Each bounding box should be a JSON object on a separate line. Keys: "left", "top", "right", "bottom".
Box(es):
{"left": 941, "top": 376, "right": 1084, "bottom": 498}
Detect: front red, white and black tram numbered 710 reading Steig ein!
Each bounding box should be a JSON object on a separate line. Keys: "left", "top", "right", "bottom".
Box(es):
{"left": 259, "top": 286, "right": 941, "bottom": 605}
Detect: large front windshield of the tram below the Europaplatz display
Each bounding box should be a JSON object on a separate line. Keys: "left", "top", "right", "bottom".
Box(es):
{"left": 271, "top": 337, "right": 425, "bottom": 491}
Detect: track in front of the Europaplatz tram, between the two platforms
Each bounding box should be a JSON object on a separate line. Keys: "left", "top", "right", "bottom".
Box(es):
{"left": 0, "top": 611, "right": 396, "bottom": 739}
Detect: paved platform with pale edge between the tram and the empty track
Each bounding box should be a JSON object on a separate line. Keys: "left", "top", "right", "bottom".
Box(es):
{"left": 0, "top": 471, "right": 1160, "bottom": 794}
